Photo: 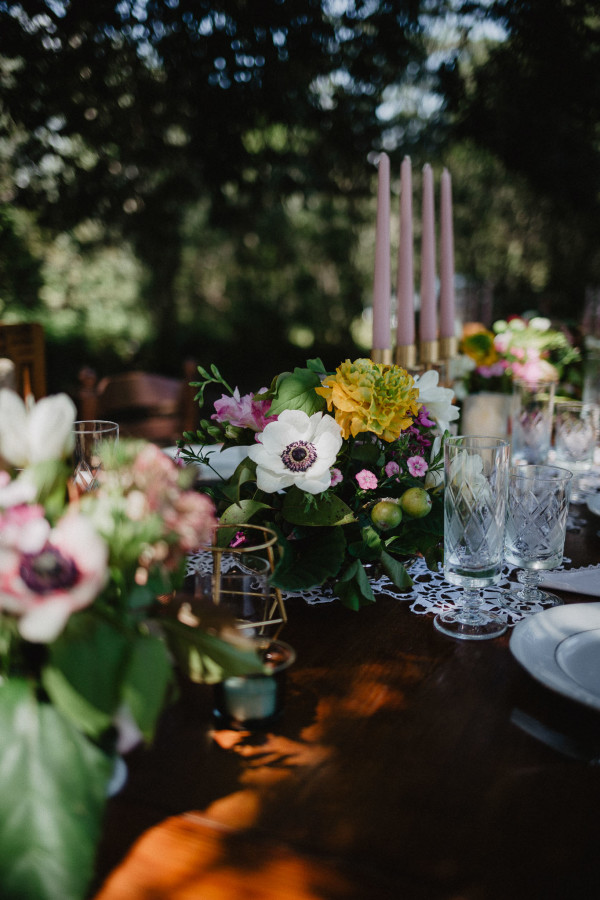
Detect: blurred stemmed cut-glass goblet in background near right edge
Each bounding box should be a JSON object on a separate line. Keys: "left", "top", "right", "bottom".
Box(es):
{"left": 554, "top": 400, "right": 600, "bottom": 503}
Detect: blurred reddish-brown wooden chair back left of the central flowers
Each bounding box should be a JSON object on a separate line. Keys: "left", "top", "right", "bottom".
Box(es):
{"left": 77, "top": 360, "right": 199, "bottom": 446}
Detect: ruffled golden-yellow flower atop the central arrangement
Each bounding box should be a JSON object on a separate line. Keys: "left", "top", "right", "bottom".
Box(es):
{"left": 315, "top": 359, "right": 421, "bottom": 441}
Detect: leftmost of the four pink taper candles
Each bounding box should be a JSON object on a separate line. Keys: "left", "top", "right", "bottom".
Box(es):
{"left": 373, "top": 153, "right": 391, "bottom": 350}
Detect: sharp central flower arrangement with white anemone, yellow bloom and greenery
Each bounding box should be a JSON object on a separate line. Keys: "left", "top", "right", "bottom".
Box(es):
{"left": 178, "top": 359, "right": 459, "bottom": 609}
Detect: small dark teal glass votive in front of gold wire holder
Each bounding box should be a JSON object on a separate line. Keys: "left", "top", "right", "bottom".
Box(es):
{"left": 213, "top": 638, "right": 296, "bottom": 729}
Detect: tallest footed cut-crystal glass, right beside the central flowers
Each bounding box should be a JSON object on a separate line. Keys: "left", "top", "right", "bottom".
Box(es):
{"left": 434, "top": 435, "right": 510, "bottom": 640}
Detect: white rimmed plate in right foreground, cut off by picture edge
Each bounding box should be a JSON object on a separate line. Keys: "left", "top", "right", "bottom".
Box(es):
{"left": 510, "top": 603, "right": 600, "bottom": 710}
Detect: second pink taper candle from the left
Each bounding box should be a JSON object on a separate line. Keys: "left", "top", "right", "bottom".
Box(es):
{"left": 396, "top": 156, "right": 415, "bottom": 347}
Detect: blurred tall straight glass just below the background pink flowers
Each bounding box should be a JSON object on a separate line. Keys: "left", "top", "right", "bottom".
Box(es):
{"left": 511, "top": 378, "right": 556, "bottom": 464}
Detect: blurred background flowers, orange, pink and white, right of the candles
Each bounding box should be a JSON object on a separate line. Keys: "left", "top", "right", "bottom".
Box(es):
{"left": 454, "top": 316, "right": 580, "bottom": 396}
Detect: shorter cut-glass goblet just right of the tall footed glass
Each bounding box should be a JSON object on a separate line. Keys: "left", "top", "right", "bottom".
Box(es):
{"left": 502, "top": 466, "right": 573, "bottom": 615}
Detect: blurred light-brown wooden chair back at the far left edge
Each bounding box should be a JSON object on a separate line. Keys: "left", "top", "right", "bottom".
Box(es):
{"left": 0, "top": 322, "right": 46, "bottom": 400}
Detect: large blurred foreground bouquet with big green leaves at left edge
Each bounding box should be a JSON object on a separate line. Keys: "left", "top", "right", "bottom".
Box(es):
{"left": 0, "top": 390, "right": 262, "bottom": 900}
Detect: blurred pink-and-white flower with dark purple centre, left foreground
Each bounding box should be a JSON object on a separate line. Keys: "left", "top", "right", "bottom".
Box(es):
{"left": 0, "top": 507, "right": 108, "bottom": 644}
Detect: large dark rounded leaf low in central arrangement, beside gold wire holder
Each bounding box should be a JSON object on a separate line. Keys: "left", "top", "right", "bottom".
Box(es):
{"left": 270, "top": 527, "right": 346, "bottom": 591}
